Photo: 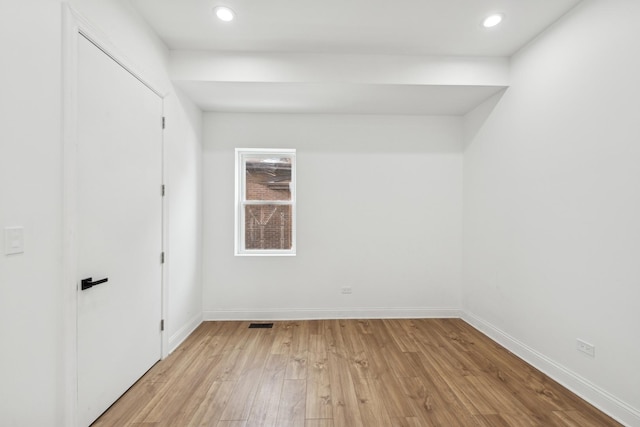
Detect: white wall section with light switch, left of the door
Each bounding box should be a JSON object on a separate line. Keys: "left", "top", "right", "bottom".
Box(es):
{"left": 0, "top": 0, "right": 64, "bottom": 426}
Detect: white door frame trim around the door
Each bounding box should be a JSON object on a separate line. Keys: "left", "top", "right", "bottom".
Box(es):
{"left": 61, "top": 3, "right": 169, "bottom": 426}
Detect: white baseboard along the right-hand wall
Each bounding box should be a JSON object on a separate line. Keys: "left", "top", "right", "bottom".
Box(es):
{"left": 461, "top": 311, "right": 640, "bottom": 426}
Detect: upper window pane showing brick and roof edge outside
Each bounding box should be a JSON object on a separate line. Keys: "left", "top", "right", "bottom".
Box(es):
{"left": 245, "top": 157, "right": 291, "bottom": 200}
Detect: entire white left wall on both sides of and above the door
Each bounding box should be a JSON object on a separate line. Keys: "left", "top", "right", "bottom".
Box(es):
{"left": 0, "top": 0, "right": 201, "bottom": 427}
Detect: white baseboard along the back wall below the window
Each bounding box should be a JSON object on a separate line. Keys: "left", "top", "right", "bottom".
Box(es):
{"left": 203, "top": 308, "right": 462, "bottom": 320}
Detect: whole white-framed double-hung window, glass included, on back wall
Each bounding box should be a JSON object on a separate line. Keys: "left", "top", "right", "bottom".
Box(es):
{"left": 235, "top": 148, "right": 296, "bottom": 255}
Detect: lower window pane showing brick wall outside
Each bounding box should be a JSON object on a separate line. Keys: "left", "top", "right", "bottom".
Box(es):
{"left": 244, "top": 205, "right": 292, "bottom": 249}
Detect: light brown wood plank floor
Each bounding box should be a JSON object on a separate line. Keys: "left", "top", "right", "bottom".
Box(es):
{"left": 94, "top": 319, "right": 620, "bottom": 427}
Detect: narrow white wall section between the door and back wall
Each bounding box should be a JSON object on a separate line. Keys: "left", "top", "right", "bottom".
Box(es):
{"left": 165, "top": 88, "right": 203, "bottom": 351}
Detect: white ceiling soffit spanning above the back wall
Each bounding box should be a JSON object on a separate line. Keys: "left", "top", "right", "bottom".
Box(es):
{"left": 170, "top": 51, "right": 509, "bottom": 115}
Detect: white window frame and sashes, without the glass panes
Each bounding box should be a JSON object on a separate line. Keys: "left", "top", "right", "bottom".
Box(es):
{"left": 234, "top": 148, "right": 296, "bottom": 256}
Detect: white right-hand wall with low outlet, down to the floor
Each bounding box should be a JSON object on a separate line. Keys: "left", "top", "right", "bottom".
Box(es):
{"left": 463, "top": 0, "right": 640, "bottom": 425}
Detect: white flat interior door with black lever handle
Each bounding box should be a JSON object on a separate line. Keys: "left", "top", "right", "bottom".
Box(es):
{"left": 77, "top": 36, "right": 162, "bottom": 426}
